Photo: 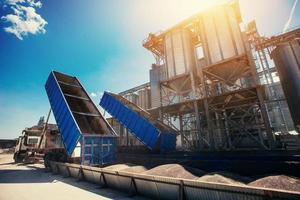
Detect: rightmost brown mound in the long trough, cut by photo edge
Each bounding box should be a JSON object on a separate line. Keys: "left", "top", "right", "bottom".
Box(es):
{"left": 248, "top": 175, "right": 300, "bottom": 192}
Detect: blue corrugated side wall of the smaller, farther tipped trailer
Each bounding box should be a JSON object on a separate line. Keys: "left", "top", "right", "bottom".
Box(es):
{"left": 100, "top": 92, "right": 159, "bottom": 149}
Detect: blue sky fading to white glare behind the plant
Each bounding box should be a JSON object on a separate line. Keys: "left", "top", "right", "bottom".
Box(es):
{"left": 0, "top": 0, "right": 300, "bottom": 139}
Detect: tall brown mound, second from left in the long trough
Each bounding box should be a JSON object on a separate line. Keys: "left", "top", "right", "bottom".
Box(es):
{"left": 142, "top": 164, "right": 203, "bottom": 180}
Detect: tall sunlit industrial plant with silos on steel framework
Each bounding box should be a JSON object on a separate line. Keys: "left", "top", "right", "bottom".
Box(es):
{"left": 109, "top": 1, "right": 300, "bottom": 151}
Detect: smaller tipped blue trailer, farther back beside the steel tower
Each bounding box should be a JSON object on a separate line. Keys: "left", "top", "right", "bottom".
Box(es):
{"left": 100, "top": 92, "right": 176, "bottom": 152}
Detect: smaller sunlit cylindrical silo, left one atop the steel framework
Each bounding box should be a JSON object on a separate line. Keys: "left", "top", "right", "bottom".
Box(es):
{"left": 165, "top": 29, "right": 195, "bottom": 78}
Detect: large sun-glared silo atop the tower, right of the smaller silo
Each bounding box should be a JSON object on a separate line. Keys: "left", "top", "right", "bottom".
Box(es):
{"left": 202, "top": 2, "right": 245, "bottom": 64}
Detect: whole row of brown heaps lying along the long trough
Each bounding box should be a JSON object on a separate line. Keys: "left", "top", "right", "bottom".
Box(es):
{"left": 104, "top": 163, "right": 300, "bottom": 192}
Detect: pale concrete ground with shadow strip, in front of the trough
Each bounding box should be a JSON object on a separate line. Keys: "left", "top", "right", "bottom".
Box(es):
{"left": 0, "top": 154, "right": 145, "bottom": 200}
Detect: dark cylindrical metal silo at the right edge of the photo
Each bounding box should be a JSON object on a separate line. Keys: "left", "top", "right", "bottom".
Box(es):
{"left": 272, "top": 39, "right": 300, "bottom": 131}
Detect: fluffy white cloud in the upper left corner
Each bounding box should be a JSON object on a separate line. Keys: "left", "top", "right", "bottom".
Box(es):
{"left": 1, "top": 0, "right": 47, "bottom": 40}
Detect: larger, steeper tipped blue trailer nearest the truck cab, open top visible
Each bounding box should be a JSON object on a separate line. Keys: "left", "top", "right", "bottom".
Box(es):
{"left": 45, "top": 71, "right": 117, "bottom": 165}
